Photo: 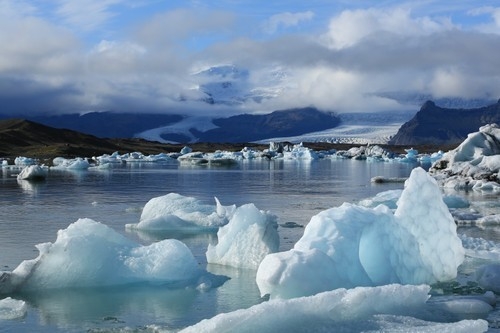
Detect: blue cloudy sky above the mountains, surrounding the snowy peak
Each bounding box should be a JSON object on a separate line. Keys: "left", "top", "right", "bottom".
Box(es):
{"left": 0, "top": 0, "right": 500, "bottom": 116}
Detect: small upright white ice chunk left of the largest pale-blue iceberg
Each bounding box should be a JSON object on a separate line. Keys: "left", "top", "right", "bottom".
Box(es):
{"left": 206, "top": 204, "right": 279, "bottom": 269}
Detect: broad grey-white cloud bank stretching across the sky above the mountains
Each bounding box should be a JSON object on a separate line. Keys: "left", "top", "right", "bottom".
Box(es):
{"left": 0, "top": 0, "right": 500, "bottom": 112}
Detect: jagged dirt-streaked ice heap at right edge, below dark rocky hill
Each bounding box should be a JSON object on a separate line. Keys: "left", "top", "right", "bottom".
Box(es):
{"left": 429, "top": 124, "right": 500, "bottom": 191}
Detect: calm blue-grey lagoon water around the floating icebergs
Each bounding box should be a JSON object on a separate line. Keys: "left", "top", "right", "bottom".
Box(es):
{"left": 0, "top": 160, "right": 458, "bottom": 332}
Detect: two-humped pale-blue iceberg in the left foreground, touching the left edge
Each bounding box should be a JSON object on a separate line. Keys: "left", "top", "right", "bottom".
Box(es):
{"left": 0, "top": 219, "right": 223, "bottom": 293}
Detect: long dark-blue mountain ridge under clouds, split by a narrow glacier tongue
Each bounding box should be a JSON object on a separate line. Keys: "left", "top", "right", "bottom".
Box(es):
{"left": 3, "top": 107, "right": 340, "bottom": 143}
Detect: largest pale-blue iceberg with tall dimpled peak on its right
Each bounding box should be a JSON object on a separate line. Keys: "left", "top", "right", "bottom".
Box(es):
{"left": 256, "top": 168, "right": 464, "bottom": 298}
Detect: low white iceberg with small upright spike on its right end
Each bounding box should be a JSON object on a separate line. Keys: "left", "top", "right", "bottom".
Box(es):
{"left": 126, "top": 193, "right": 236, "bottom": 231}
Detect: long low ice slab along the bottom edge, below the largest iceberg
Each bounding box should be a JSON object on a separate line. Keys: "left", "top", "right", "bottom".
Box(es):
{"left": 181, "top": 284, "right": 488, "bottom": 333}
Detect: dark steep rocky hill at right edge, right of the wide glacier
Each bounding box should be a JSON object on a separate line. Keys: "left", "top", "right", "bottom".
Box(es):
{"left": 389, "top": 101, "right": 500, "bottom": 145}
